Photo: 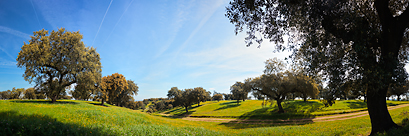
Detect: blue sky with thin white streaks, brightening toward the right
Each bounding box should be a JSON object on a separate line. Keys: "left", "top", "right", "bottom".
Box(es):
{"left": 0, "top": 0, "right": 289, "bottom": 100}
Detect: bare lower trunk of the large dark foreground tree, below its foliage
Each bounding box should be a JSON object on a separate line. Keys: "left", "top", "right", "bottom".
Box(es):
{"left": 367, "top": 88, "right": 398, "bottom": 135}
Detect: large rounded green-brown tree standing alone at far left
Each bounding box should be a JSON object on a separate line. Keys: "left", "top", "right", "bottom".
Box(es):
{"left": 17, "top": 28, "right": 101, "bottom": 102}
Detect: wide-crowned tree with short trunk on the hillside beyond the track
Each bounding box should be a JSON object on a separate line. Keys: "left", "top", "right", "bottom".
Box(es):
{"left": 230, "top": 58, "right": 321, "bottom": 113}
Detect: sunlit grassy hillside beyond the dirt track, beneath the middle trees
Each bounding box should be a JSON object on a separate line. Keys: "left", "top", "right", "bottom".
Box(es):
{"left": 161, "top": 100, "right": 409, "bottom": 119}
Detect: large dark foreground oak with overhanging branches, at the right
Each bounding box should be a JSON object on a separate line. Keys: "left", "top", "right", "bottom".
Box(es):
{"left": 226, "top": 0, "right": 409, "bottom": 134}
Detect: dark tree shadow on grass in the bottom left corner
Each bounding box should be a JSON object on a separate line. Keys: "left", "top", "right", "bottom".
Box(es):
{"left": 0, "top": 111, "right": 107, "bottom": 136}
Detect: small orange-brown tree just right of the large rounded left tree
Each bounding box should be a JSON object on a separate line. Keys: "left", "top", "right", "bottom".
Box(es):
{"left": 100, "top": 73, "right": 128, "bottom": 106}
